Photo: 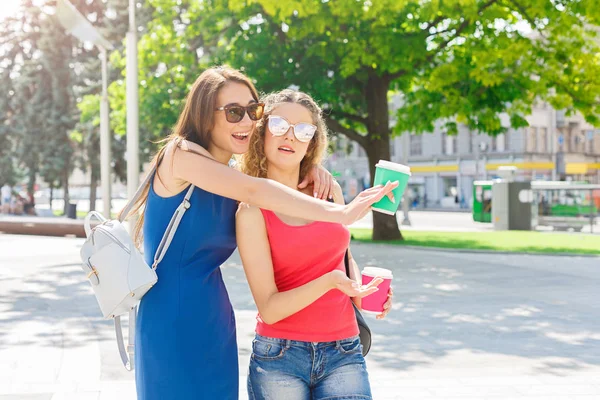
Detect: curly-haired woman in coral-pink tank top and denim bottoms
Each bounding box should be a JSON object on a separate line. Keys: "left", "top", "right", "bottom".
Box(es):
{"left": 236, "top": 89, "right": 391, "bottom": 400}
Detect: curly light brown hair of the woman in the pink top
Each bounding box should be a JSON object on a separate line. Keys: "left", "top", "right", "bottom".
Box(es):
{"left": 241, "top": 89, "right": 328, "bottom": 182}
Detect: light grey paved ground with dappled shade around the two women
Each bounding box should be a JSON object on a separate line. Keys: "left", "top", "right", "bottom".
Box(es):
{"left": 0, "top": 235, "right": 600, "bottom": 400}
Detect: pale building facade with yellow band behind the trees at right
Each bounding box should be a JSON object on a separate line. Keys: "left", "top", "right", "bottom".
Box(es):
{"left": 327, "top": 104, "right": 600, "bottom": 208}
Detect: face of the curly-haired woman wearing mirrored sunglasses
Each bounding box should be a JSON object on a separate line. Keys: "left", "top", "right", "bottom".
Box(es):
{"left": 265, "top": 103, "right": 314, "bottom": 170}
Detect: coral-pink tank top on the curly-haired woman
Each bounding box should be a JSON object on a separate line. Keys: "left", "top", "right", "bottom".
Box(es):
{"left": 256, "top": 210, "right": 359, "bottom": 342}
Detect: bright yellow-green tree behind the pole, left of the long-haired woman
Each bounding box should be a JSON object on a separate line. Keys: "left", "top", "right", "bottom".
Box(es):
{"left": 109, "top": 2, "right": 192, "bottom": 148}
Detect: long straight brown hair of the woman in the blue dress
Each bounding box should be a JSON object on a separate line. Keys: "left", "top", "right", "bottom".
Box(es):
{"left": 122, "top": 66, "right": 258, "bottom": 247}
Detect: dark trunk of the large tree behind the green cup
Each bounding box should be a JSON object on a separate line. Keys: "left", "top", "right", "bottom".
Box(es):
{"left": 365, "top": 73, "right": 403, "bottom": 240}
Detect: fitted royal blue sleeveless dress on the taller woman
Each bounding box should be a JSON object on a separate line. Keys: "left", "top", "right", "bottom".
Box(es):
{"left": 135, "top": 184, "right": 239, "bottom": 400}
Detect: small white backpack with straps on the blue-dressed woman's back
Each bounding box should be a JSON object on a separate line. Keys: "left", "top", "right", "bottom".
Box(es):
{"left": 80, "top": 167, "right": 194, "bottom": 371}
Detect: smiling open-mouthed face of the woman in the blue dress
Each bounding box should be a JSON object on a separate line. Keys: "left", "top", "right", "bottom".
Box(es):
{"left": 209, "top": 82, "right": 256, "bottom": 160}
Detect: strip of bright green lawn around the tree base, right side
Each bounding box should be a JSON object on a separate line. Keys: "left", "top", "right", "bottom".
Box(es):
{"left": 350, "top": 228, "right": 600, "bottom": 254}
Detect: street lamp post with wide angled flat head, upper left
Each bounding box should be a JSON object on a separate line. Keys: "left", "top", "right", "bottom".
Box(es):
{"left": 56, "top": 0, "right": 113, "bottom": 218}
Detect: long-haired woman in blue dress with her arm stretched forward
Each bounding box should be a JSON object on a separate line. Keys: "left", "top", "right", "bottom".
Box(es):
{"left": 127, "top": 67, "right": 394, "bottom": 400}
